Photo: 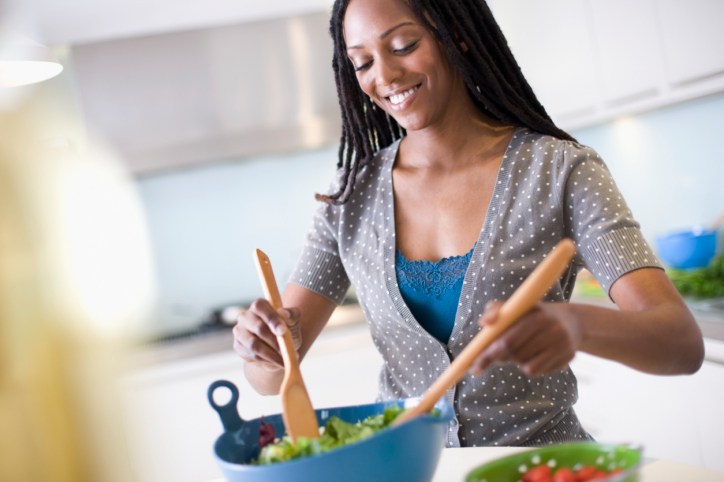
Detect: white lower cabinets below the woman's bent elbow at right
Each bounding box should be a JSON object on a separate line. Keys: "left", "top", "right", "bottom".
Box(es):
{"left": 571, "top": 339, "right": 724, "bottom": 472}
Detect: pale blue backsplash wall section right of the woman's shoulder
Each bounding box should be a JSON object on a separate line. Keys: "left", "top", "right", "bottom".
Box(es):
{"left": 572, "top": 94, "right": 724, "bottom": 242}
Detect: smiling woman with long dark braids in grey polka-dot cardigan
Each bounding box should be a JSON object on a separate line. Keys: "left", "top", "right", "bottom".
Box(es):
{"left": 234, "top": 0, "right": 703, "bottom": 446}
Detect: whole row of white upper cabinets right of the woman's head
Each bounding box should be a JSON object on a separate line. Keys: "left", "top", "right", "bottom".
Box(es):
{"left": 489, "top": 0, "right": 724, "bottom": 129}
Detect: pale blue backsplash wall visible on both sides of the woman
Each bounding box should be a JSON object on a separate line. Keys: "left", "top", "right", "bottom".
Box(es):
{"left": 138, "top": 95, "right": 724, "bottom": 333}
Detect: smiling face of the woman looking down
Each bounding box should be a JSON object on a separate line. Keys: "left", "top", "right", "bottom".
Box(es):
{"left": 344, "top": 0, "right": 466, "bottom": 131}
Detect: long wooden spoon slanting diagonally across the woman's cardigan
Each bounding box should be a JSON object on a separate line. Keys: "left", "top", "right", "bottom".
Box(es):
{"left": 393, "top": 238, "right": 576, "bottom": 425}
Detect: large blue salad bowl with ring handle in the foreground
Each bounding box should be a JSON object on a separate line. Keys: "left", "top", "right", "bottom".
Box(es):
{"left": 208, "top": 380, "right": 454, "bottom": 482}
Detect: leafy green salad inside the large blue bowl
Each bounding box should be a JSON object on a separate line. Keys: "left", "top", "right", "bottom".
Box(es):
{"left": 254, "top": 405, "right": 404, "bottom": 465}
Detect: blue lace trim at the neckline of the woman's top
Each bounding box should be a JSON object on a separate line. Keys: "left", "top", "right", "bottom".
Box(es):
{"left": 395, "top": 247, "right": 475, "bottom": 299}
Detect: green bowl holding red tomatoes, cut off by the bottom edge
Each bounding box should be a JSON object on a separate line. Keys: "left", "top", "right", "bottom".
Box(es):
{"left": 465, "top": 442, "right": 641, "bottom": 482}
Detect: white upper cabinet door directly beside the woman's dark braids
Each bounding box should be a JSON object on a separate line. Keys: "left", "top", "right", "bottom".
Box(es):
{"left": 489, "top": 0, "right": 598, "bottom": 122}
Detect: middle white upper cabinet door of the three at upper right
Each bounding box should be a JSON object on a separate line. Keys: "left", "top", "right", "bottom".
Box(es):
{"left": 590, "top": 0, "right": 663, "bottom": 105}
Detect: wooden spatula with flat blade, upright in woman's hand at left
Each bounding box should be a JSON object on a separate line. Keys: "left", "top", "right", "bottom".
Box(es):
{"left": 254, "top": 249, "right": 319, "bottom": 442}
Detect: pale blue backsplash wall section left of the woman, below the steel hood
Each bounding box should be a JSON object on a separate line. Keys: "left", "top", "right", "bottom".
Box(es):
{"left": 138, "top": 147, "right": 337, "bottom": 334}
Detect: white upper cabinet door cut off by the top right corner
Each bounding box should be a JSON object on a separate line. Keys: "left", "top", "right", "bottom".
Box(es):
{"left": 656, "top": 0, "right": 724, "bottom": 84}
